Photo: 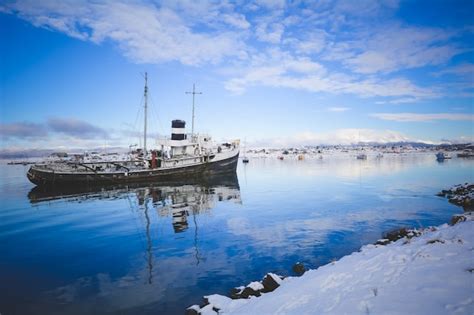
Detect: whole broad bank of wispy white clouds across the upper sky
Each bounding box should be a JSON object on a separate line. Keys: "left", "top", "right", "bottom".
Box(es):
{"left": 0, "top": 0, "right": 472, "bottom": 100}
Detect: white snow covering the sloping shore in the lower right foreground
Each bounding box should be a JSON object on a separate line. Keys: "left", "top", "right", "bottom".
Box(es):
{"left": 193, "top": 213, "right": 474, "bottom": 315}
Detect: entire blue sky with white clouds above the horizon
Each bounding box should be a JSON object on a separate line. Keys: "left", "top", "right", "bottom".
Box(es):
{"left": 0, "top": 0, "right": 474, "bottom": 149}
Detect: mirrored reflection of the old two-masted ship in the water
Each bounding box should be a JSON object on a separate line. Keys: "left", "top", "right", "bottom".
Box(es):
{"left": 28, "top": 174, "right": 241, "bottom": 243}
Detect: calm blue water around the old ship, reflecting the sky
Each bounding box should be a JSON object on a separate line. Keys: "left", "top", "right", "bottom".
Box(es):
{"left": 0, "top": 154, "right": 474, "bottom": 314}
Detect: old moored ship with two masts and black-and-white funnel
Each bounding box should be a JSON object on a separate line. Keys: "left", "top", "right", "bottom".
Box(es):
{"left": 27, "top": 73, "right": 240, "bottom": 186}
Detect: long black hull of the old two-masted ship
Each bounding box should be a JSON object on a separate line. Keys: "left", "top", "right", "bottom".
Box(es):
{"left": 27, "top": 154, "right": 239, "bottom": 187}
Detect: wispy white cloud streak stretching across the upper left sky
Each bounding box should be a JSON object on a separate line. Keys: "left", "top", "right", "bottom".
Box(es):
{"left": 2, "top": 1, "right": 248, "bottom": 65}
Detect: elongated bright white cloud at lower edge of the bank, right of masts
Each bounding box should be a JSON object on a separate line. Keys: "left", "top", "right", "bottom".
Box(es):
{"left": 225, "top": 50, "right": 439, "bottom": 98}
